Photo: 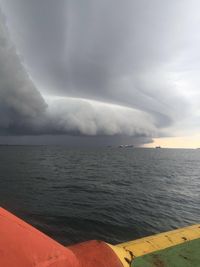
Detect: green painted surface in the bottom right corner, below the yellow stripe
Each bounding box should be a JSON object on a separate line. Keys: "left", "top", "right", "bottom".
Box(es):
{"left": 131, "top": 238, "right": 200, "bottom": 267}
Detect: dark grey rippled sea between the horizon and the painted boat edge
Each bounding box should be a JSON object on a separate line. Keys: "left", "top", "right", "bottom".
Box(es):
{"left": 0, "top": 146, "right": 200, "bottom": 244}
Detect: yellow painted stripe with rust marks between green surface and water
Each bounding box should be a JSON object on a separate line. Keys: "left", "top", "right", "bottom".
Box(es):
{"left": 108, "top": 224, "right": 200, "bottom": 267}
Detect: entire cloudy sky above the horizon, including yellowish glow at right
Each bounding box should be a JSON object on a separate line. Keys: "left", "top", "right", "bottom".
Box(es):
{"left": 0, "top": 0, "right": 200, "bottom": 147}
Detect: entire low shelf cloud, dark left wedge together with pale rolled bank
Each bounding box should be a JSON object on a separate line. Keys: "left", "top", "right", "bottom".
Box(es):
{"left": 0, "top": 7, "right": 156, "bottom": 142}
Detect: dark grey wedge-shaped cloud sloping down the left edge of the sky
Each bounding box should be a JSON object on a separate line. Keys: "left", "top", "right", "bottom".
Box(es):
{"left": 0, "top": 9, "right": 45, "bottom": 135}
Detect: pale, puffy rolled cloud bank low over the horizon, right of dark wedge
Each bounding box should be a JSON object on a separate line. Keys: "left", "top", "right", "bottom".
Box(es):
{"left": 46, "top": 97, "right": 156, "bottom": 136}
